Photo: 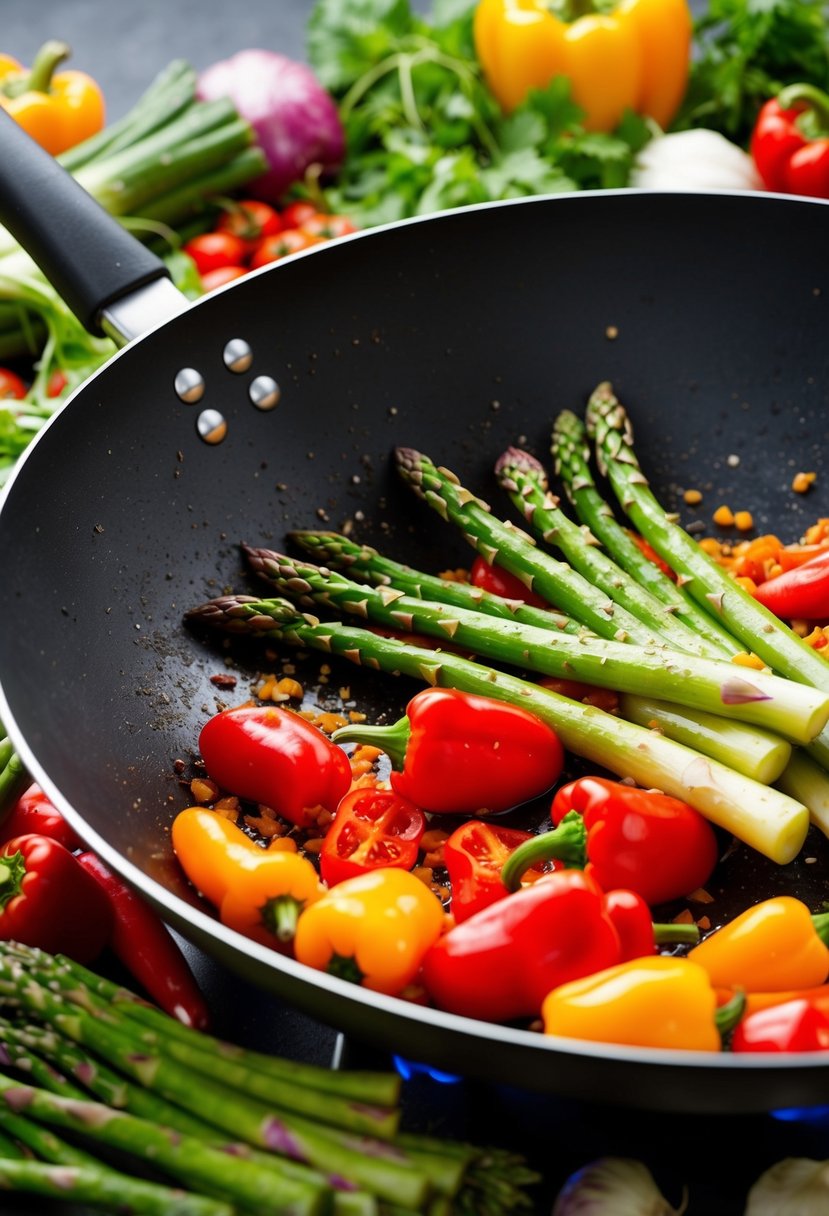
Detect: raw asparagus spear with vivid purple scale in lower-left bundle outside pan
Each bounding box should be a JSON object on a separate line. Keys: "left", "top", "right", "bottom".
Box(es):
{"left": 0, "top": 957, "right": 430, "bottom": 1207}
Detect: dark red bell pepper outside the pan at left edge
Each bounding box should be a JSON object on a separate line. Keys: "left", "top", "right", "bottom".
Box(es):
{"left": 0, "top": 834, "right": 112, "bottom": 963}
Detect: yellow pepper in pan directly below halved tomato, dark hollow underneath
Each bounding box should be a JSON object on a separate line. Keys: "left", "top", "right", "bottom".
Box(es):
{"left": 294, "top": 867, "right": 445, "bottom": 996}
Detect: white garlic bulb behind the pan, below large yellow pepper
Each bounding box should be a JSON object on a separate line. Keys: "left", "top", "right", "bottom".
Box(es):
{"left": 630, "top": 126, "right": 763, "bottom": 190}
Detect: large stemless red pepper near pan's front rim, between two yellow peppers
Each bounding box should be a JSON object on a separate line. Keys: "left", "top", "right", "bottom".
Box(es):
{"left": 423, "top": 869, "right": 621, "bottom": 1021}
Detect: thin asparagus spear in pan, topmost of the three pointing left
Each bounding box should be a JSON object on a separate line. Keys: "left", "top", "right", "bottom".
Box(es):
{"left": 286, "top": 530, "right": 585, "bottom": 634}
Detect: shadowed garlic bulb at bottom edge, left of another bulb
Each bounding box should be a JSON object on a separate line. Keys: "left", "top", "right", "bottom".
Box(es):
{"left": 551, "top": 1156, "right": 686, "bottom": 1216}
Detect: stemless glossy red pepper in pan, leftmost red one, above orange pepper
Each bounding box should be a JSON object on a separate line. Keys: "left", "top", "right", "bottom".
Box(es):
{"left": 198, "top": 705, "right": 351, "bottom": 827}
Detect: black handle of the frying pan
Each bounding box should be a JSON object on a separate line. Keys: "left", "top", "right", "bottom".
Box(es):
{"left": 0, "top": 108, "right": 170, "bottom": 336}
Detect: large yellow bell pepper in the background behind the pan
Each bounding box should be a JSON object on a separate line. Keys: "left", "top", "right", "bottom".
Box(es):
{"left": 474, "top": 0, "right": 692, "bottom": 131}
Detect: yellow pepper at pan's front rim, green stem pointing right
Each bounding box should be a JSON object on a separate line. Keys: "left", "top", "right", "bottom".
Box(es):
{"left": 541, "top": 955, "right": 741, "bottom": 1052}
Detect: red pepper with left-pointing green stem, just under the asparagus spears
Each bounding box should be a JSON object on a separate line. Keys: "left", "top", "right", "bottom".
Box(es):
{"left": 333, "top": 688, "right": 564, "bottom": 815}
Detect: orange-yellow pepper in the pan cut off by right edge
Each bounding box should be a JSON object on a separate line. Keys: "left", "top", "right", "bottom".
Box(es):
{"left": 688, "top": 895, "right": 829, "bottom": 992}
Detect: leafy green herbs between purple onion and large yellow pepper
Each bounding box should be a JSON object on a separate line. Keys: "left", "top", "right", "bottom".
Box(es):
{"left": 308, "top": 0, "right": 650, "bottom": 227}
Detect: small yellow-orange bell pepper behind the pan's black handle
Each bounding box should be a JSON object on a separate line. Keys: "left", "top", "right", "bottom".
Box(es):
{"left": 0, "top": 40, "right": 106, "bottom": 156}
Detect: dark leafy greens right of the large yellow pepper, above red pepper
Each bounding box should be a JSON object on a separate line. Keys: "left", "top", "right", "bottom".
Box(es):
{"left": 673, "top": 0, "right": 829, "bottom": 147}
